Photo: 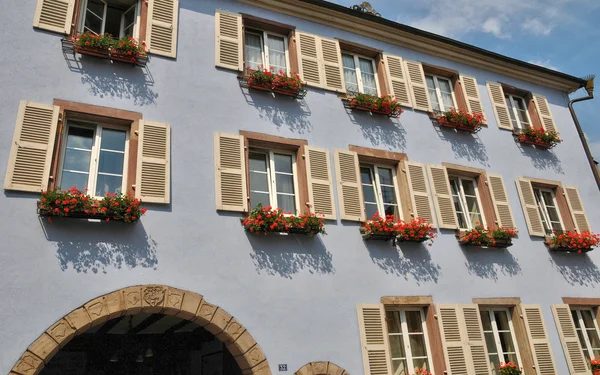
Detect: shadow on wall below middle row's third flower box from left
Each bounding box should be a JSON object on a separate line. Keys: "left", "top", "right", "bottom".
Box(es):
{"left": 365, "top": 241, "right": 441, "bottom": 285}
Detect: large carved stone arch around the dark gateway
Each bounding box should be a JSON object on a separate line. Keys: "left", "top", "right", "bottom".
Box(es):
{"left": 9, "top": 285, "right": 270, "bottom": 375}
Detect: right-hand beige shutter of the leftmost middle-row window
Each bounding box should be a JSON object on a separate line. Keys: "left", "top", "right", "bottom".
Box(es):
{"left": 135, "top": 120, "right": 171, "bottom": 204}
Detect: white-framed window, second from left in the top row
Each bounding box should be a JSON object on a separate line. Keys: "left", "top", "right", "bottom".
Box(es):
{"left": 245, "top": 30, "right": 289, "bottom": 73}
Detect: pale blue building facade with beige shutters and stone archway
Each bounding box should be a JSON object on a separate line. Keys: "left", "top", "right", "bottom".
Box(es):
{"left": 0, "top": 0, "right": 600, "bottom": 375}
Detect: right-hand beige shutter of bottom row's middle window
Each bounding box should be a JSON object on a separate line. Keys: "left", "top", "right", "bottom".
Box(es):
{"left": 521, "top": 305, "right": 556, "bottom": 375}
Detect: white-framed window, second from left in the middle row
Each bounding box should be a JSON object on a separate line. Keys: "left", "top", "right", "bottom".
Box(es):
{"left": 249, "top": 148, "right": 299, "bottom": 214}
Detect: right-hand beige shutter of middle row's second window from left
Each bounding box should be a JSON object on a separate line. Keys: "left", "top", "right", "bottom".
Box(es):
{"left": 304, "top": 146, "right": 336, "bottom": 220}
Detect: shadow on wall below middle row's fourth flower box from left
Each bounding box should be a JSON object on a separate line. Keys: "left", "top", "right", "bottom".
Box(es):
{"left": 461, "top": 246, "right": 522, "bottom": 281}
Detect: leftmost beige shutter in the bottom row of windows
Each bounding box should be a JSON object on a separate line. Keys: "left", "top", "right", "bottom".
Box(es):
{"left": 357, "top": 304, "right": 392, "bottom": 375}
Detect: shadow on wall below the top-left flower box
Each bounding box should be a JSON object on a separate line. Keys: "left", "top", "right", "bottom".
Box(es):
{"left": 63, "top": 53, "right": 158, "bottom": 106}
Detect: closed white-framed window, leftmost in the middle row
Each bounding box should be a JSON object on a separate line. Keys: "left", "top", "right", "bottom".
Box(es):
{"left": 59, "top": 121, "right": 129, "bottom": 197}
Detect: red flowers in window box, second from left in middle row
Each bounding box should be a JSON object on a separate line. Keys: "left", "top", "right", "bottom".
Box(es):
{"left": 242, "top": 203, "right": 327, "bottom": 236}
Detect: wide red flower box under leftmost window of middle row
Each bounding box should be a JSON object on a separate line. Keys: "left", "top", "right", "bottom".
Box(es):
{"left": 39, "top": 186, "right": 147, "bottom": 223}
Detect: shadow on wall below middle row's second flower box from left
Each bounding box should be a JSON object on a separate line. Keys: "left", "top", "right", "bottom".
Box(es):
{"left": 247, "top": 233, "right": 335, "bottom": 279}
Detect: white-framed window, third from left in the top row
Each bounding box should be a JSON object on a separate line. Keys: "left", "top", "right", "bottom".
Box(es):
{"left": 342, "top": 53, "right": 379, "bottom": 96}
